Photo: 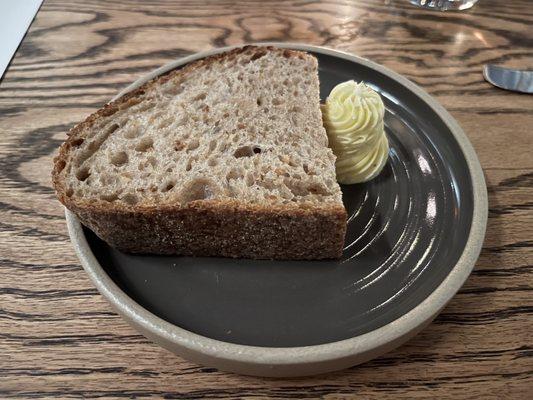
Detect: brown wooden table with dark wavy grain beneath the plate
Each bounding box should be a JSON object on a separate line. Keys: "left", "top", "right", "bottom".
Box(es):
{"left": 0, "top": 0, "right": 533, "bottom": 399}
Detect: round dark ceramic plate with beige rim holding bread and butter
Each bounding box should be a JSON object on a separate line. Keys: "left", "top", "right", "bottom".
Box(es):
{"left": 67, "top": 44, "right": 487, "bottom": 376}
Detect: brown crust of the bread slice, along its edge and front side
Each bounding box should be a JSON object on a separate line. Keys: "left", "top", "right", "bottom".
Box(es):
{"left": 52, "top": 46, "right": 346, "bottom": 259}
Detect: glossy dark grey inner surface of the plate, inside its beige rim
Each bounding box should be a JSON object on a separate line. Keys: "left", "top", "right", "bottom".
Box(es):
{"left": 85, "top": 53, "right": 473, "bottom": 347}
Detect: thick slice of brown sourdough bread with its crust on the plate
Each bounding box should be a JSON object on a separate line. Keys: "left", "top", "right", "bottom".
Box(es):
{"left": 52, "top": 46, "right": 346, "bottom": 259}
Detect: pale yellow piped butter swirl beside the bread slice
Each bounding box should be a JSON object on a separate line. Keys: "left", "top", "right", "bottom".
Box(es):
{"left": 322, "top": 80, "right": 389, "bottom": 184}
